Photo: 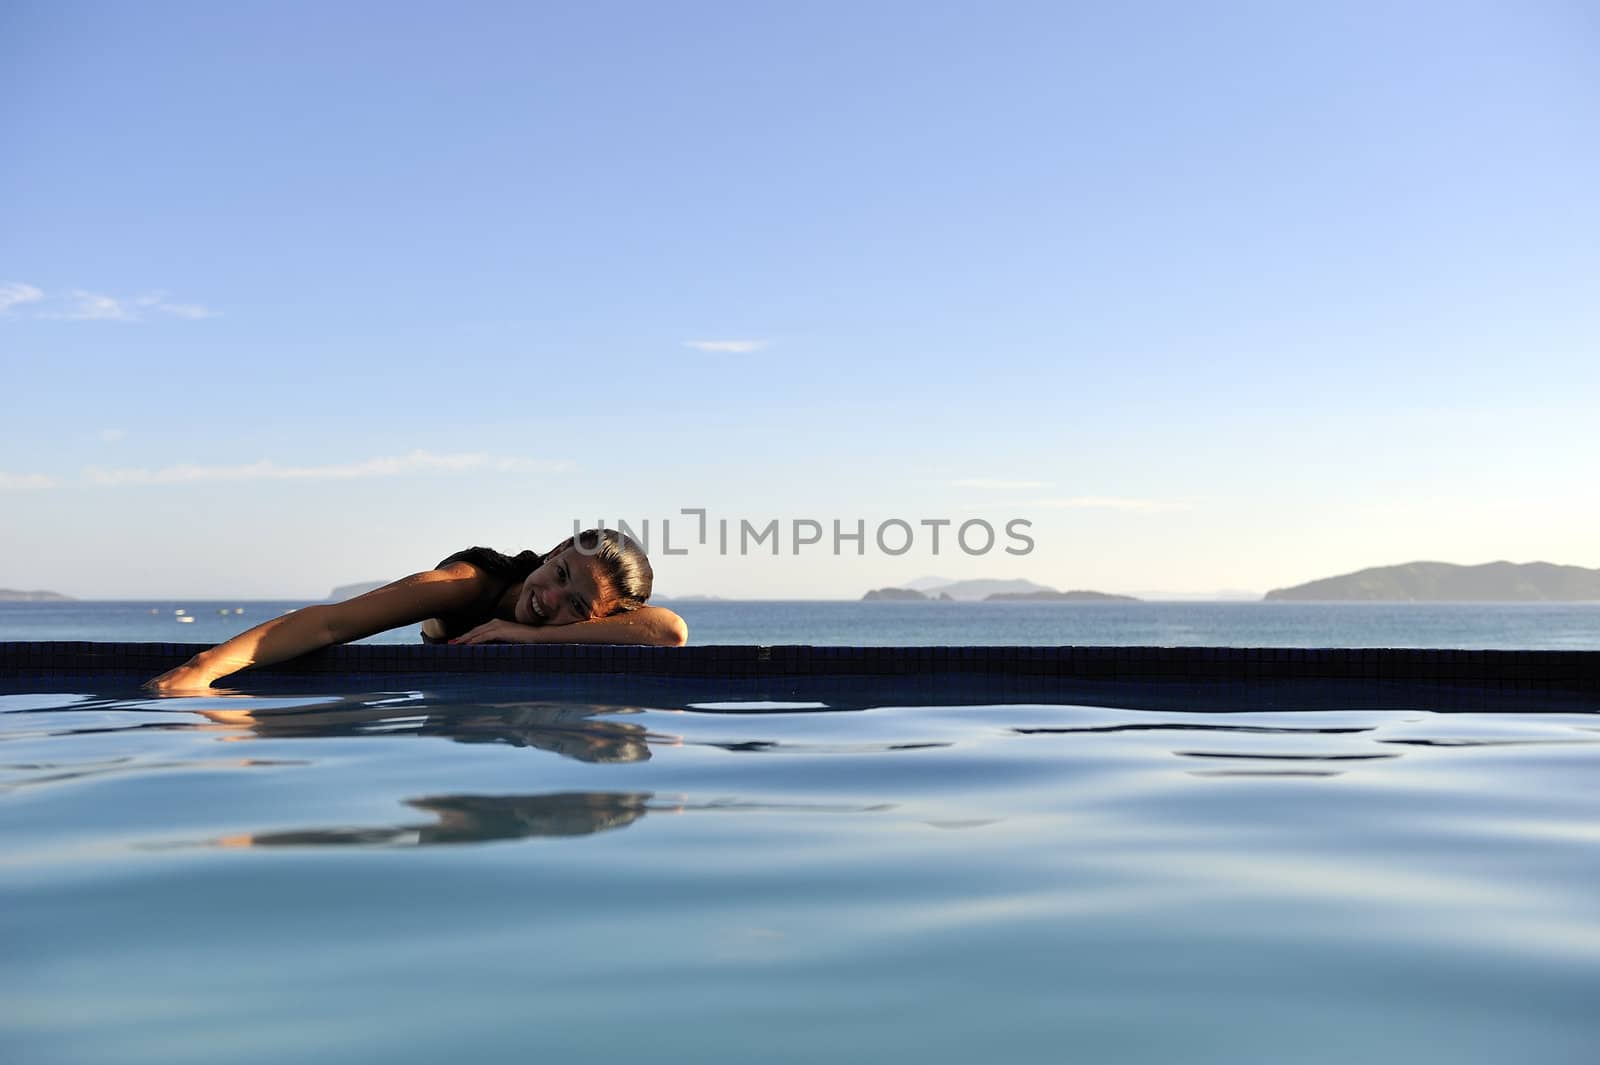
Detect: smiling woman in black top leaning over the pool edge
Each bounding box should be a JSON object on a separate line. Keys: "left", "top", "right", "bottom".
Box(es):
{"left": 146, "top": 529, "right": 688, "bottom": 692}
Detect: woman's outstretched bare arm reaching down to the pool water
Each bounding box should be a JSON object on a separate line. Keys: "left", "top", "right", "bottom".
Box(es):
{"left": 144, "top": 563, "right": 483, "bottom": 692}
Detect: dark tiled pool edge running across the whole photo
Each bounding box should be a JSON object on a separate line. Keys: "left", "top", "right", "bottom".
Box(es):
{"left": 0, "top": 641, "right": 1600, "bottom": 712}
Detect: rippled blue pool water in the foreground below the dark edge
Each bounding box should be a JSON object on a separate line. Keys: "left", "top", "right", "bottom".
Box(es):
{"left": 0, "top": 680, "right": 1600, "bottom": 1065}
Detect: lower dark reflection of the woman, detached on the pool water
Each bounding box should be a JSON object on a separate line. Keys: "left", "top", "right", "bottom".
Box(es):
{"left": 179, "top": 792, "right": 893, "bottom": 848}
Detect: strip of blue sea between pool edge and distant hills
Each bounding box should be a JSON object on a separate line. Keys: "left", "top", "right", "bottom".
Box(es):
{"left": 0, "top": 600, "right": 1600, "bottom": 651}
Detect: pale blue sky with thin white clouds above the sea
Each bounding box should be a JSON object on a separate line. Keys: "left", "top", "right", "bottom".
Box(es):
{"left": 0, "top": 2, "right": 1600, "bottom": 598}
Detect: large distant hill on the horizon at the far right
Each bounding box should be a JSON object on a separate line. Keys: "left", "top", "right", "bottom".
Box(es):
{"left": 1266, "top": 561, "right": 1600, "bottom": 603}
